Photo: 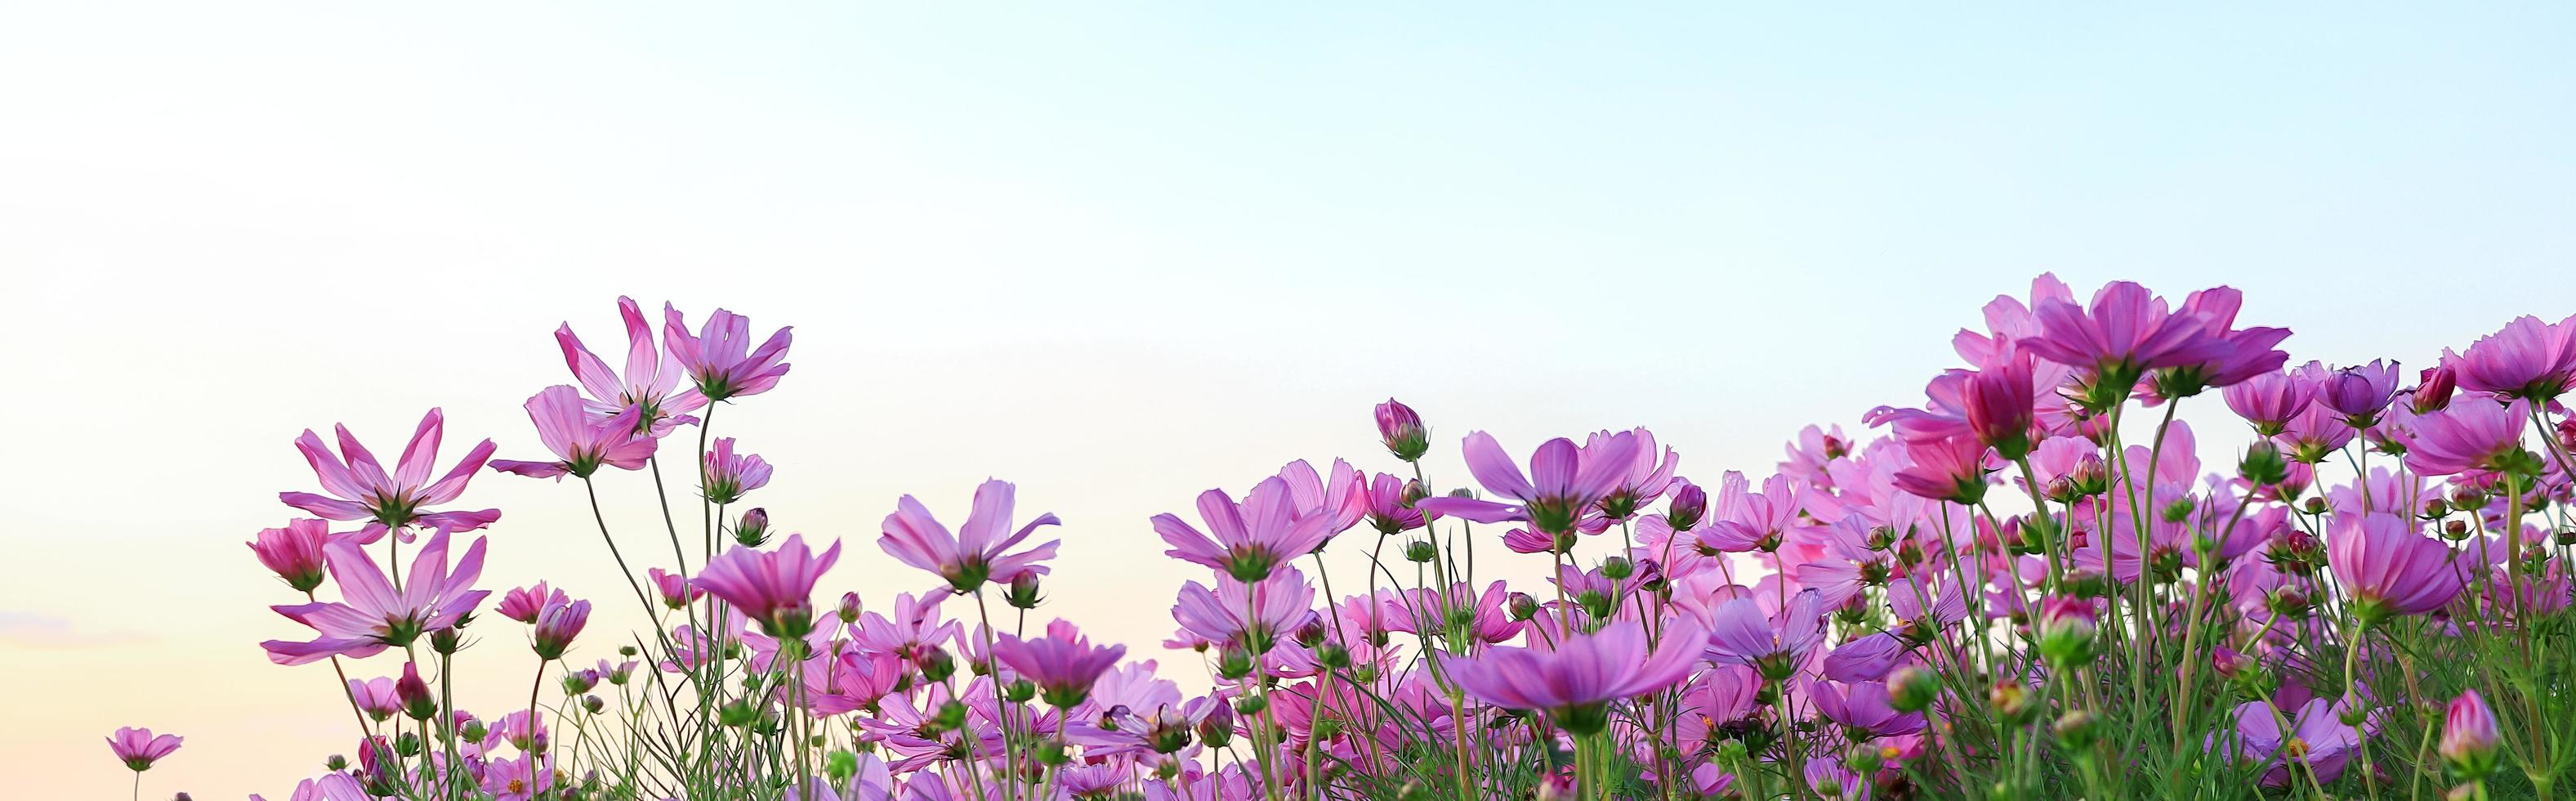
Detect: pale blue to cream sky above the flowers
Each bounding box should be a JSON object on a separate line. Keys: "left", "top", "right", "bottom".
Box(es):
{"left": 0, "top": 2, "right": 2576, "bottom": 799}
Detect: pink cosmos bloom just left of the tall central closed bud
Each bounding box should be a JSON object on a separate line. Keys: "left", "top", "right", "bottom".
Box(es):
{"left": 1154, "top": 476, "right": 1339, "bottom": 582}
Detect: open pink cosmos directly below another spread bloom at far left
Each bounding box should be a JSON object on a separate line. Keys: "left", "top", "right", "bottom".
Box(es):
{"left": 260, "top": 530, "right": 492, "bottom": 665}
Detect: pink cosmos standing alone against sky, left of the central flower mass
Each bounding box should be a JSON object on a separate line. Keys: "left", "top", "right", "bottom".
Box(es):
{"left": 876, "top": 479, "right": 1061, "bottom": 593}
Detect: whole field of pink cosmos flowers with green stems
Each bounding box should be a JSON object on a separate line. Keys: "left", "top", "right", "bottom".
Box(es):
{"left": 115, "top": 275, "right": 2576, "bottom": 801}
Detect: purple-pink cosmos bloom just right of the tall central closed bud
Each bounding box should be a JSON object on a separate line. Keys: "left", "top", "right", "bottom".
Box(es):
{"left": 1414, "top": 430, "right": 1638, "bottom": 535}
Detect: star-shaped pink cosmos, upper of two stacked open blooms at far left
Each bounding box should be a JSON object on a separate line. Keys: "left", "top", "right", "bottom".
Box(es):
{"left": 279, "top": 409, "right": 500, "bottom": 544}
